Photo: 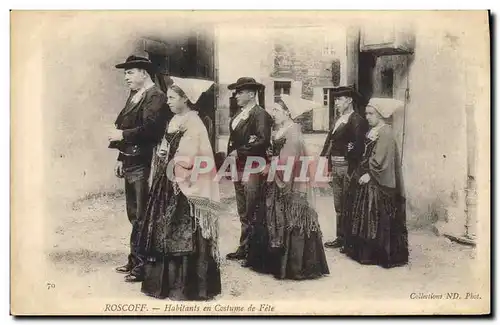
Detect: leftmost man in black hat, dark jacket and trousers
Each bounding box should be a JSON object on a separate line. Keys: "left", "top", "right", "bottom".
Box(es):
{"left": 108, "top": 56, "right": 168, "bottom": 282}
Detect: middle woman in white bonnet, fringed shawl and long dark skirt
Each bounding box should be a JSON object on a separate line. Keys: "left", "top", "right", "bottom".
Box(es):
{"left": 246, "top": 95, "right": 329, "bottom": 280}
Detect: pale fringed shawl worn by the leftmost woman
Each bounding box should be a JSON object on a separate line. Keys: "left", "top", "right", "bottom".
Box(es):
{"left": 174, "top": 111, "right": 224, "bottom": 265}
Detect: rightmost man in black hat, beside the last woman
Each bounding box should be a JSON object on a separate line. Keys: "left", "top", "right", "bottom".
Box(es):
{"left": 320, "top": 87, "right": 368, "bottom": 248}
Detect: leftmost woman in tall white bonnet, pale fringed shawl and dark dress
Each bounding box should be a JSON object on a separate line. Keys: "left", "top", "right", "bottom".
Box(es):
{"left": 137, "top": 77, "right": 221, "bottom": 300}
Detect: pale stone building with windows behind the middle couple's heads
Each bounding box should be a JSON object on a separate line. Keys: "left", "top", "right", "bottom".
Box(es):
{"left": 217, "top": 25, "right": 346, "bottom": 135}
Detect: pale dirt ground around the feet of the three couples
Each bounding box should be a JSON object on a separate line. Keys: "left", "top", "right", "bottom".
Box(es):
{"left": 47, "top": 178, "right": 474, "bottom": 306}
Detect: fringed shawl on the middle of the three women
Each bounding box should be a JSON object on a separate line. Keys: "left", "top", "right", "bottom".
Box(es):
{"left": 267, "top": 124, "right": 320, "bottom": 243}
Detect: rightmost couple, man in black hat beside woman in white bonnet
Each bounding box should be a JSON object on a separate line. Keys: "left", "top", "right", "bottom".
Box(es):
{"left": 320, "top": 87, "right": 409, "bottom": 268}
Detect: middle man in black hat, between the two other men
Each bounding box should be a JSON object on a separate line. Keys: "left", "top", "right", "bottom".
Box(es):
{"left": 227, "top": 77, "right": 272, "bottom": 260}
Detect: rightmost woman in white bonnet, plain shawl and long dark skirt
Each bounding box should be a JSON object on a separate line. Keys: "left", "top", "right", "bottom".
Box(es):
{"left": 343, "top": 98, "right": 408, "bottom": 268}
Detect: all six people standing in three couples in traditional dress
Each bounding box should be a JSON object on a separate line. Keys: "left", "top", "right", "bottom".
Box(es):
{"left": 108, "top": 56, "right": 408, "bottom": 300}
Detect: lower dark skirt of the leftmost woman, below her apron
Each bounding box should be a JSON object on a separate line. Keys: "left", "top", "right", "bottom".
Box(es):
{"left": 141, "top": 228, "right": 221, "bottom": 300}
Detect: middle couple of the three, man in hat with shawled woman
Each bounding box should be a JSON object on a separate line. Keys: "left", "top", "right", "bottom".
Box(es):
{"left": 226, "top": 77, "right": 329, "bottom": 279}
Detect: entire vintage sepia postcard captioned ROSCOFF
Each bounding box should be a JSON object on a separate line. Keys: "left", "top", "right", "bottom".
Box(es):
{"left": 10, "top": 10, "right": 491, "bottom": 316}
